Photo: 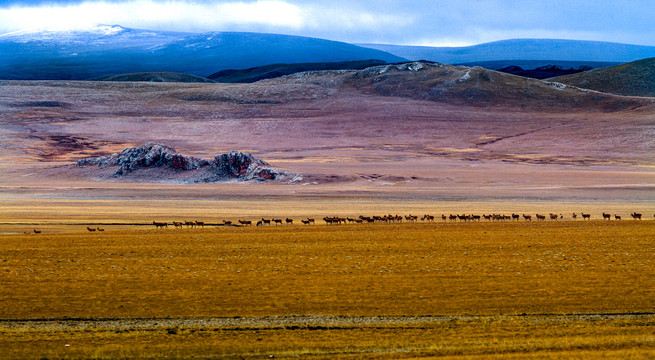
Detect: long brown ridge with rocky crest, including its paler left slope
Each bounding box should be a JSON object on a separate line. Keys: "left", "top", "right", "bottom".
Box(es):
{"left": 174, "top": 61, "right": 652, "bottom": 111}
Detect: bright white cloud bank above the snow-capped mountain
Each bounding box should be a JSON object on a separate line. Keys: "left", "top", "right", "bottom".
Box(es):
{"left": 0, "top": 0, "right": 305, "bottom": 31}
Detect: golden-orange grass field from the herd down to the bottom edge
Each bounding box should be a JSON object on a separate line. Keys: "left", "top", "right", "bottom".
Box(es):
{"left": 0, "top": 210, "right": 655, "bottom": 359}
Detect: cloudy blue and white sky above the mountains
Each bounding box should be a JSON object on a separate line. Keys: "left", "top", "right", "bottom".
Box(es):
{"left": 0, "top": 0, "right": 655, "bottom": 46}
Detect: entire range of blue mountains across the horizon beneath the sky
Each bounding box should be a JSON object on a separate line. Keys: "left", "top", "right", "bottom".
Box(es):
{"left": 0, "top": 25, "right": 655, "bottom": 84}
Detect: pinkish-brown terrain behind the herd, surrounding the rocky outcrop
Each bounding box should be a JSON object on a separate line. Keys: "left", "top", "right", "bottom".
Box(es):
{"left": 0, "top": 63, "right": 655, "bottom": 218}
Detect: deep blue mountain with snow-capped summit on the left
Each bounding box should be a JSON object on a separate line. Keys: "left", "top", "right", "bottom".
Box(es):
{"left": 0, "top": 25, "right": 404, "bottom": 79}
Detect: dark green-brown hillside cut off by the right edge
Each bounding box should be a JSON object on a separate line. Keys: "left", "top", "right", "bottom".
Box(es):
{"left": 550, "top": 58, "right": 655, "bottom": 97}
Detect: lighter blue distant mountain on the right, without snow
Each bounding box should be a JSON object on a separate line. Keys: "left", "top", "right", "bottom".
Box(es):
{"left": 358, "top": 39, "right": 655, "bottom": 67}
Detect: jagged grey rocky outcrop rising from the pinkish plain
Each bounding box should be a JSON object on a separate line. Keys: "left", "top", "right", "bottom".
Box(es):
{"left": 75, "top": 143, "right": 299, "bottom": 183}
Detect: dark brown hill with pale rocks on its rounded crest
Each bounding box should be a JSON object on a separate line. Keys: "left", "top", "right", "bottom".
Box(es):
{"left": 347, "top": 62, "right": 648, "bottom": 111}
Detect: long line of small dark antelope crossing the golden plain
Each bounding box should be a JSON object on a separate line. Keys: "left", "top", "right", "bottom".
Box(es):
{"left": 151, "top": 212, "right": 655, "bottom": 231}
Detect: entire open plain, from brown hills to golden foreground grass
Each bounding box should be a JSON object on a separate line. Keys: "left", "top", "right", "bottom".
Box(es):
{"left": 0, "top": 63, "right": 655, "bottom": 359}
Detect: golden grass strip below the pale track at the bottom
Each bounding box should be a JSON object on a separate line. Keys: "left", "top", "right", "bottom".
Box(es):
{"left": 0, "top": 315, "right": 655, "bottom": 359}
